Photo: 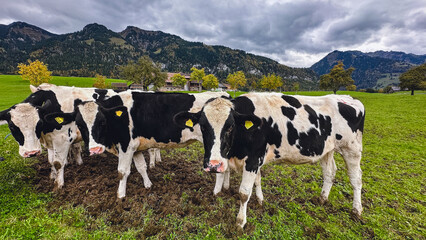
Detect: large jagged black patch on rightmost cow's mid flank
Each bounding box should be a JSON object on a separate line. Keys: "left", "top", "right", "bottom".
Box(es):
{"left": 287, "top": 114, "right": 332, "bottom": 156}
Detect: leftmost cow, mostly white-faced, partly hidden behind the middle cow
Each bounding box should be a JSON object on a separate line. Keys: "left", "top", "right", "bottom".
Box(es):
{"left": 0, "top": 84, "right": 120, "bottom": 189}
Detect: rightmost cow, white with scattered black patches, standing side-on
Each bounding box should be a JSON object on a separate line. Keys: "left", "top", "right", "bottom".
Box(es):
{"left": 175, "top": 93, "right": 365, "bottom": 228}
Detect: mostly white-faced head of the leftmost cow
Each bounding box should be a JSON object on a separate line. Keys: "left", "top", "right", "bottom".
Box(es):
{"left": 0, "top": 100, "right": 51, "bottom": 158}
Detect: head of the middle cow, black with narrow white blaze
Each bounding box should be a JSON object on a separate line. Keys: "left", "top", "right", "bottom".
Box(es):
{"left": 46, "top": 101, "right": 129, "bottom": 155}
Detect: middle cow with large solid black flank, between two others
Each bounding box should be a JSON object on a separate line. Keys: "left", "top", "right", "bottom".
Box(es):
{"left": 47, "top": 90, "right": 229, "bottom": 198}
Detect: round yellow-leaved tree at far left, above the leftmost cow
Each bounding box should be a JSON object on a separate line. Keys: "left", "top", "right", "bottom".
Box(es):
{"left": 18, "top": 60, "right": 52, "bottom": 86}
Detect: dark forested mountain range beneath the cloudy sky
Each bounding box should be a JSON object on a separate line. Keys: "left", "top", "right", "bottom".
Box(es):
{"left": 0, "top": 22, "right": 426, "bottom": 90}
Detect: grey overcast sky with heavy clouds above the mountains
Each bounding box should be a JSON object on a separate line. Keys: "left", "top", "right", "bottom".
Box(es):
{"left": 0, "top": 0, "right": 426, "bottom": 67}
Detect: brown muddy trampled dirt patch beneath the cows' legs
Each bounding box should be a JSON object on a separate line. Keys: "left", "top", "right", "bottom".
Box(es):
{"left": 33, "top": 151, "right": 263, "bottom": 238}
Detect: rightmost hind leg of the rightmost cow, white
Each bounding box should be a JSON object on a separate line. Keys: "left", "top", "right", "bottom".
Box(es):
{"left": 342, "top": 150, "right": 362, "bottom": 217}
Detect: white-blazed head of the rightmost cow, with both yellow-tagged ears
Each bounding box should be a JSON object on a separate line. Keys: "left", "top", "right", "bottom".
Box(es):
{"left": 174, "top": 98, "right": 262, "bottom": 172}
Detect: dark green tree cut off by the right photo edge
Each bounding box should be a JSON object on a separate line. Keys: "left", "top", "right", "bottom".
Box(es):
{"left": 399, "top": 63, "right": 426, "bottom": 95}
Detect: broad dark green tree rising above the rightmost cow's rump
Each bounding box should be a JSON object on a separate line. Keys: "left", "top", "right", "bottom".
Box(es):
{"left": 319, "top": 61, "right": 355, "bottom": 94}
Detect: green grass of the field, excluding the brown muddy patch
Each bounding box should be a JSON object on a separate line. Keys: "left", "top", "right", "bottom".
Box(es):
{"left": 0, "top": 75, "right": 426, "bottom": 239}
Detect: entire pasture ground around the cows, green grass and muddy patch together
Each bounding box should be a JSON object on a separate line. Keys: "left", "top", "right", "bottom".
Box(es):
{"left": 0, "top": 75, "right": 426, "bottom": 239}
